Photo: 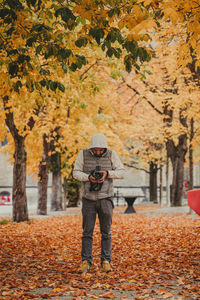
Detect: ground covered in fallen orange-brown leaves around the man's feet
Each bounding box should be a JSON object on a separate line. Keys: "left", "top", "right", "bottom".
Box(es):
{"left": 0, "top": 208, "right": 200, "bottom": 299}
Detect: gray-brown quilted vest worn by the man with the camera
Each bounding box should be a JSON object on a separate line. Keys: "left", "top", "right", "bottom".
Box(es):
{"left": 82, "top": 149, "right": 114, "bottom": 201}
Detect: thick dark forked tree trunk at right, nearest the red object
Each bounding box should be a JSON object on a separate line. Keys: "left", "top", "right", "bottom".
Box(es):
{"left": 167, "top": 134, "right": 187, "bottom": 206}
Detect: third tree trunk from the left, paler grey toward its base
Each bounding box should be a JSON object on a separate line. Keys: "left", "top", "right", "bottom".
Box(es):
{"left": 51, "top": 152, "right": 63, "bottom": 211}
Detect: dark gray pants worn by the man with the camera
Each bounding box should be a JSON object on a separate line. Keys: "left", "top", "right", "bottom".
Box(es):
{"left": 81, "top": 198, "right": 113, "bottom": 264}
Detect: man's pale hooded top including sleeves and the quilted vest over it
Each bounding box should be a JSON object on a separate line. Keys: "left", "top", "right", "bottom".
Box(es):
{"left": 73, "top": 134, "right": 125, "bottom": 200}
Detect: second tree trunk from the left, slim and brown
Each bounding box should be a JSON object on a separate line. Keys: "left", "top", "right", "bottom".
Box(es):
{"left": 37, "top": 134, "right": 49, "bottom": 215}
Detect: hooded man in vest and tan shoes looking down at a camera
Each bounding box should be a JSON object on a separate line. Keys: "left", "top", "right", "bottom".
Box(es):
{"left": 73, "top": 134, "right": 125, "bottom": 273}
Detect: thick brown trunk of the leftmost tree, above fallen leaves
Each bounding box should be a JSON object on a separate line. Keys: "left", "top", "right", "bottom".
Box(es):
{"left": 12, "top": 135, "right": 28, "bottom": 222}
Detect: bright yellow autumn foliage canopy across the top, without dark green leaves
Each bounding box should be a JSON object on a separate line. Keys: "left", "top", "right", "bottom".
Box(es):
{"left": 0, "top": 0, "right": 200, "bottom": 180}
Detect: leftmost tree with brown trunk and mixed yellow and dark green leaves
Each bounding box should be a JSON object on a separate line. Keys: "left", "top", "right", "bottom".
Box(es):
{"left": 0, "top": 0, "right": 156, "bottom": 222}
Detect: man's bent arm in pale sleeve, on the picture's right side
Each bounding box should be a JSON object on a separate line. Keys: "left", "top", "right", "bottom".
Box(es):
{"left": 108, "top": 151, "right": 125, "bottom": 179}
